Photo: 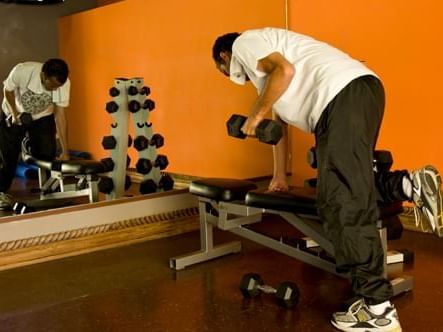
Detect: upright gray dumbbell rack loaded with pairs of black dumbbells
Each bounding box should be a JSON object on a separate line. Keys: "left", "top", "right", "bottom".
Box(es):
{"left": 99, "top": 77, "right": 173, "bottom": 199}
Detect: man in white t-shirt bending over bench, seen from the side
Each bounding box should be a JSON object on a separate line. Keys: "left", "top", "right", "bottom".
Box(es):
{"left": 212, "top": 28, "right": 442, "bottom": 331}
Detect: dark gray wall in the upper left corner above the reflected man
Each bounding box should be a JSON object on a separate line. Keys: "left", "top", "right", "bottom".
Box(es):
{"left": 0, "top": 0, "right": 97, "bottom": 83}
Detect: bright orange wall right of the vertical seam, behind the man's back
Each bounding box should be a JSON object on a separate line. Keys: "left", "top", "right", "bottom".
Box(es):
{"left": 289, "top": 0, "right": 443, "bottom": 181}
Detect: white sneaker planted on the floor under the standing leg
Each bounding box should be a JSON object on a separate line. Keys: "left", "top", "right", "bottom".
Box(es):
{"left": 331, "top": 299, "right": 401, "bottom": 332}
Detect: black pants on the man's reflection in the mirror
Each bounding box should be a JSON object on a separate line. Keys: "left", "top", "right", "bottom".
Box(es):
{"left": 0, "top": 115, "right": 56, "bottom": 192}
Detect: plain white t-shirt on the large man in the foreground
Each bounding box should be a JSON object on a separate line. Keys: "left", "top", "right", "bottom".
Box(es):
{"left": 230, "top": 28, "right": 376, "bottom": 132}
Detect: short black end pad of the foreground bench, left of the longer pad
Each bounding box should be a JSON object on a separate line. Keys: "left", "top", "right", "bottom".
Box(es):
{"left": 189, "top": 178, "right": 257, "bottom": 202}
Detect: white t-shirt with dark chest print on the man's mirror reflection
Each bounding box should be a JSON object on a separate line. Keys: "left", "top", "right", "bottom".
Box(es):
{"left": 2, "top": 62, "right": 71, "bottom": 120}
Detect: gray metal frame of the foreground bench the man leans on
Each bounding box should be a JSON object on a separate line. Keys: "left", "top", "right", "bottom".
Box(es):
{"left": 169, "top": 197, "right": 413, "bottom": 295}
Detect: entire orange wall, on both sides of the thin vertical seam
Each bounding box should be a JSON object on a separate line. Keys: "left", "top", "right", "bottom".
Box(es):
{"left": 60, "top": 0, "right": 443, "bottom": 183}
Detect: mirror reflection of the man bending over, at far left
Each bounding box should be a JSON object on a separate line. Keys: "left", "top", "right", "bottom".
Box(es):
{"left": 0, "top": 59, "right": 70, "bottom": 210}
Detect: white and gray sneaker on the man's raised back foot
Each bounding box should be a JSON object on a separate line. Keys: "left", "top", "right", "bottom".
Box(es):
{"left": 411, "top": 165, "right": 443, "bottom": 236}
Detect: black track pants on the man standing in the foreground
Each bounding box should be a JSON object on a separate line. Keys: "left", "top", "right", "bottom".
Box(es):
{"left": 315, "top": 76, "right": 398, "bottom": 304}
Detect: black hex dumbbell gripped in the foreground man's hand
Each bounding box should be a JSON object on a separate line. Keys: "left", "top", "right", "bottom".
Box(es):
{"left": 226, "top": 114, "right": 283, "bottom": 145}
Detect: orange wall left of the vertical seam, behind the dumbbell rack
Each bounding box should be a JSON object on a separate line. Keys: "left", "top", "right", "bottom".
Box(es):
{"left": 59, "top": 0, "right": 284, "bottom": 178}
